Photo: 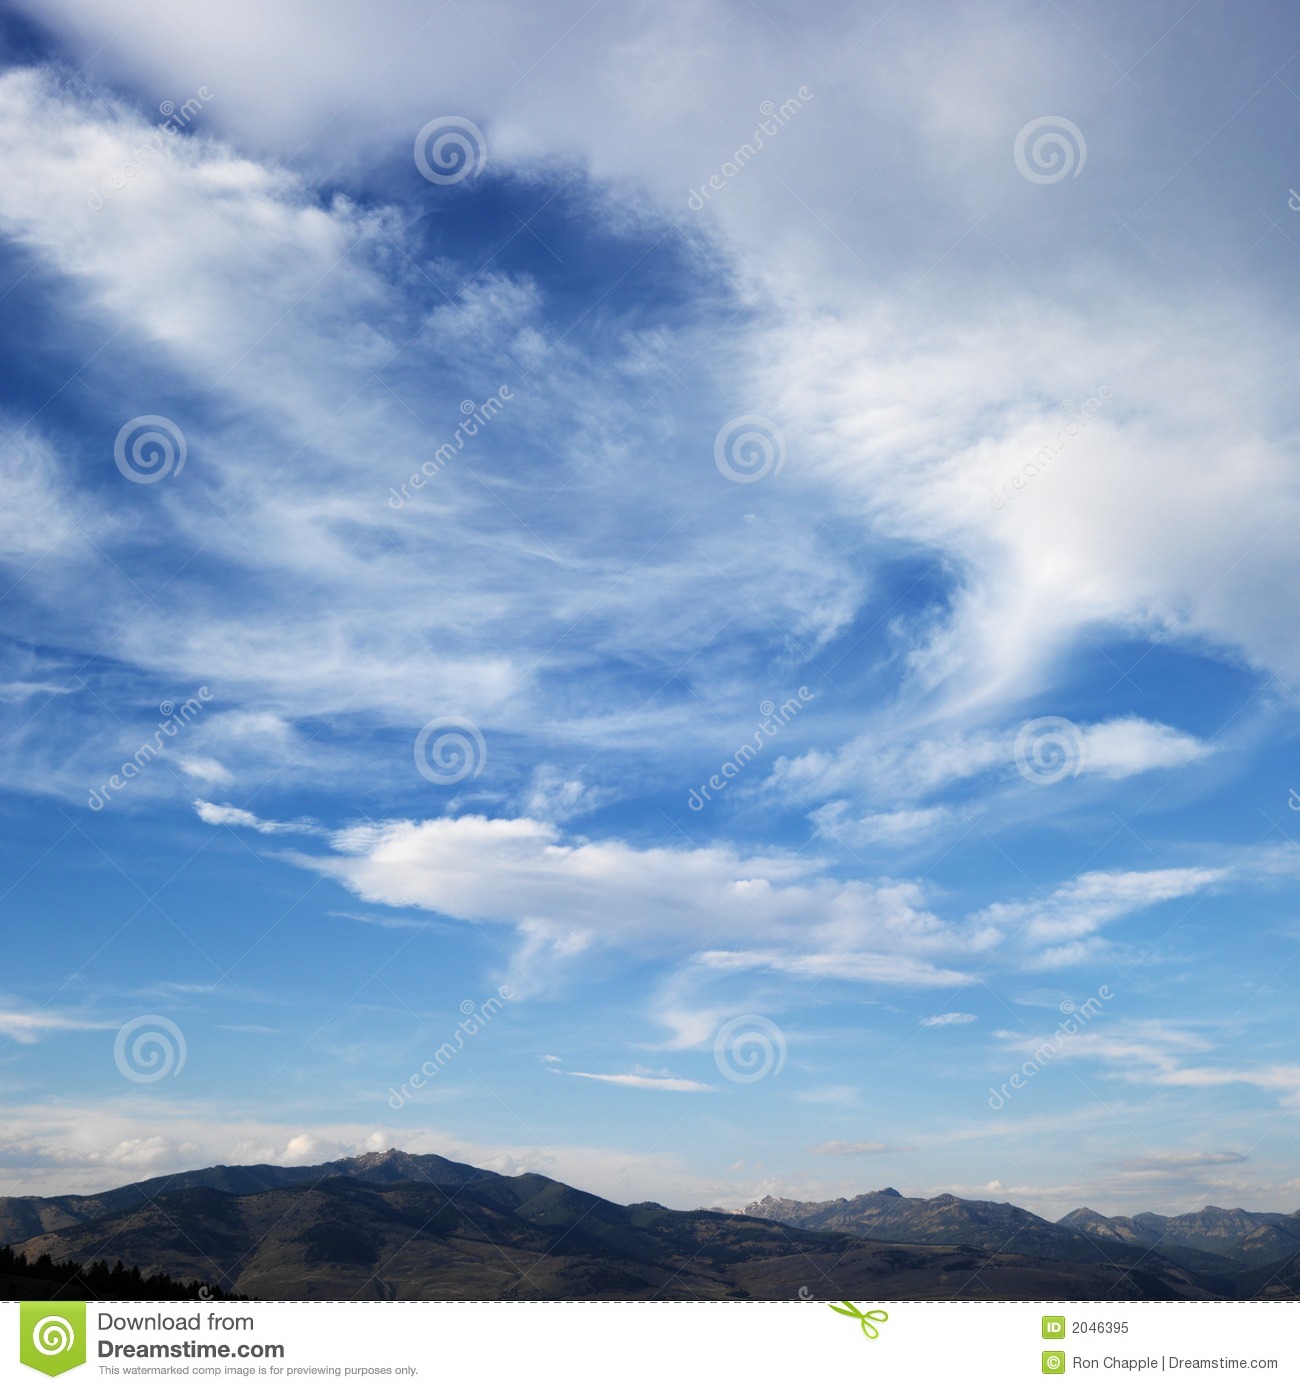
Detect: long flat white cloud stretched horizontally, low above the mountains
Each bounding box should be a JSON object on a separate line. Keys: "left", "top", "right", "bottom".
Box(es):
{"left": 226, "top": 802, "right": 1251, "bottom": 989}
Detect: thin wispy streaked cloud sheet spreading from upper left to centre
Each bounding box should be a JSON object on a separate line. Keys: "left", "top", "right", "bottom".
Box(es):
{"left": 0, "top": 70, "right": 865, "bottom": 816}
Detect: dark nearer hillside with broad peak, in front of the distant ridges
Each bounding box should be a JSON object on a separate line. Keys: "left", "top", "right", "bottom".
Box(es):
{"left": 10, "top": 1154, "right": 1211, "bottom": 1298}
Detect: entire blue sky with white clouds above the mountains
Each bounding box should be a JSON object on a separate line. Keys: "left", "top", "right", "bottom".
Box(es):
{"left": 0, "top": 0, "right": 1300, "bottom": 1215}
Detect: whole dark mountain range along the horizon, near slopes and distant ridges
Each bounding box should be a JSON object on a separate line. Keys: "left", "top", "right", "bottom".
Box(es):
{"left": 0, "top": 1150, "right": 1300, "bottom": 1300}
